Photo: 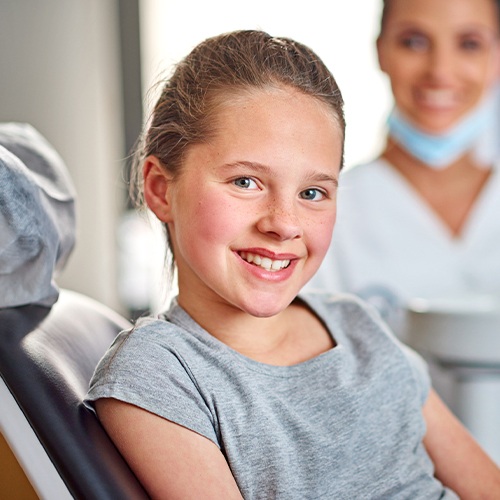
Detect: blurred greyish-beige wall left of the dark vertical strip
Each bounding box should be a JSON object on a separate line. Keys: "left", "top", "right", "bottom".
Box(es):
{"left": 0, "top": 0, "right": 124, "bottom": 307}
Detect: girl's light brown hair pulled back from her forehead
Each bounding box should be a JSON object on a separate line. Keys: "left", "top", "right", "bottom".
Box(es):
{"left": 131, "top": 30, "right": 345, "bottom": 204}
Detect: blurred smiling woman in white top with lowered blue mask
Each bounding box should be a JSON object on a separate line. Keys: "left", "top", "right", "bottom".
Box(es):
{"left": 309, "top": 0, "right": 500, "bottom": 318}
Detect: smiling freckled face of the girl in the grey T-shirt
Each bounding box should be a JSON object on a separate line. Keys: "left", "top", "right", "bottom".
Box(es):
{"left": 162, "top": 90, "right": 342, "bottom": 317}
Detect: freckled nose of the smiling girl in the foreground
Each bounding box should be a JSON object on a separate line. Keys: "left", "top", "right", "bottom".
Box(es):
{"left": 257, "top": 203, "right": 303, "bottom": 241}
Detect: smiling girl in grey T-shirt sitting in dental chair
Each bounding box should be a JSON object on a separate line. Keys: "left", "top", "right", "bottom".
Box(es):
{"left": 87, "top": 31, "right": 500, "bottom": 499}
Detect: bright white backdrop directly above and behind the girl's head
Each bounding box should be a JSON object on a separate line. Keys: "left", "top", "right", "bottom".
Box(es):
{"left": 141, "top": 0, "right": 391, "bottom": 166}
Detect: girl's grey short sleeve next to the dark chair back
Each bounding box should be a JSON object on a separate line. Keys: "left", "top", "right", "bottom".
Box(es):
{"left": 84, "top": 326, "right": 220, "bottom": 447}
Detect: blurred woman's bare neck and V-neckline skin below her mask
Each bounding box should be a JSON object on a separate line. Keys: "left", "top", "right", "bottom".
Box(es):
{"left": 381, "top": 138, "right": 491, "bottom": 237}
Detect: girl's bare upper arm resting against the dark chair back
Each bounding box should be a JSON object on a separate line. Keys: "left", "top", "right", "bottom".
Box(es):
{"left": 96, "top": 399, "right": 242, "bottom": 500}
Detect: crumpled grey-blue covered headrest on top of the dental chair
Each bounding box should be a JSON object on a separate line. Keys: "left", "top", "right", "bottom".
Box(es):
{"left": 0, "top": 123, "right": 76, "bottom": 307}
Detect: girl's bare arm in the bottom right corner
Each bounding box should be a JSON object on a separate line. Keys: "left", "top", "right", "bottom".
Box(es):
{"left": 423, "top": 391, "right": 500, "bottom": 500}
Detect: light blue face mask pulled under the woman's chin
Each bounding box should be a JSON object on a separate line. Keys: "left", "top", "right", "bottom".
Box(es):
{"left": 387, "top": 94, "right": 496, "bottom": 170}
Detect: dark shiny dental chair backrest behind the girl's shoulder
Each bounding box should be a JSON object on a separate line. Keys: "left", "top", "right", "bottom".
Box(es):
{"left": 0, "top": 290, "right": 147, "bottom": 500}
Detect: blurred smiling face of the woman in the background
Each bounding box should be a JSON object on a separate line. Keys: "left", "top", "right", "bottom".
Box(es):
{"left": 377, "top": 0, "right": 500, "bottom": 133}
